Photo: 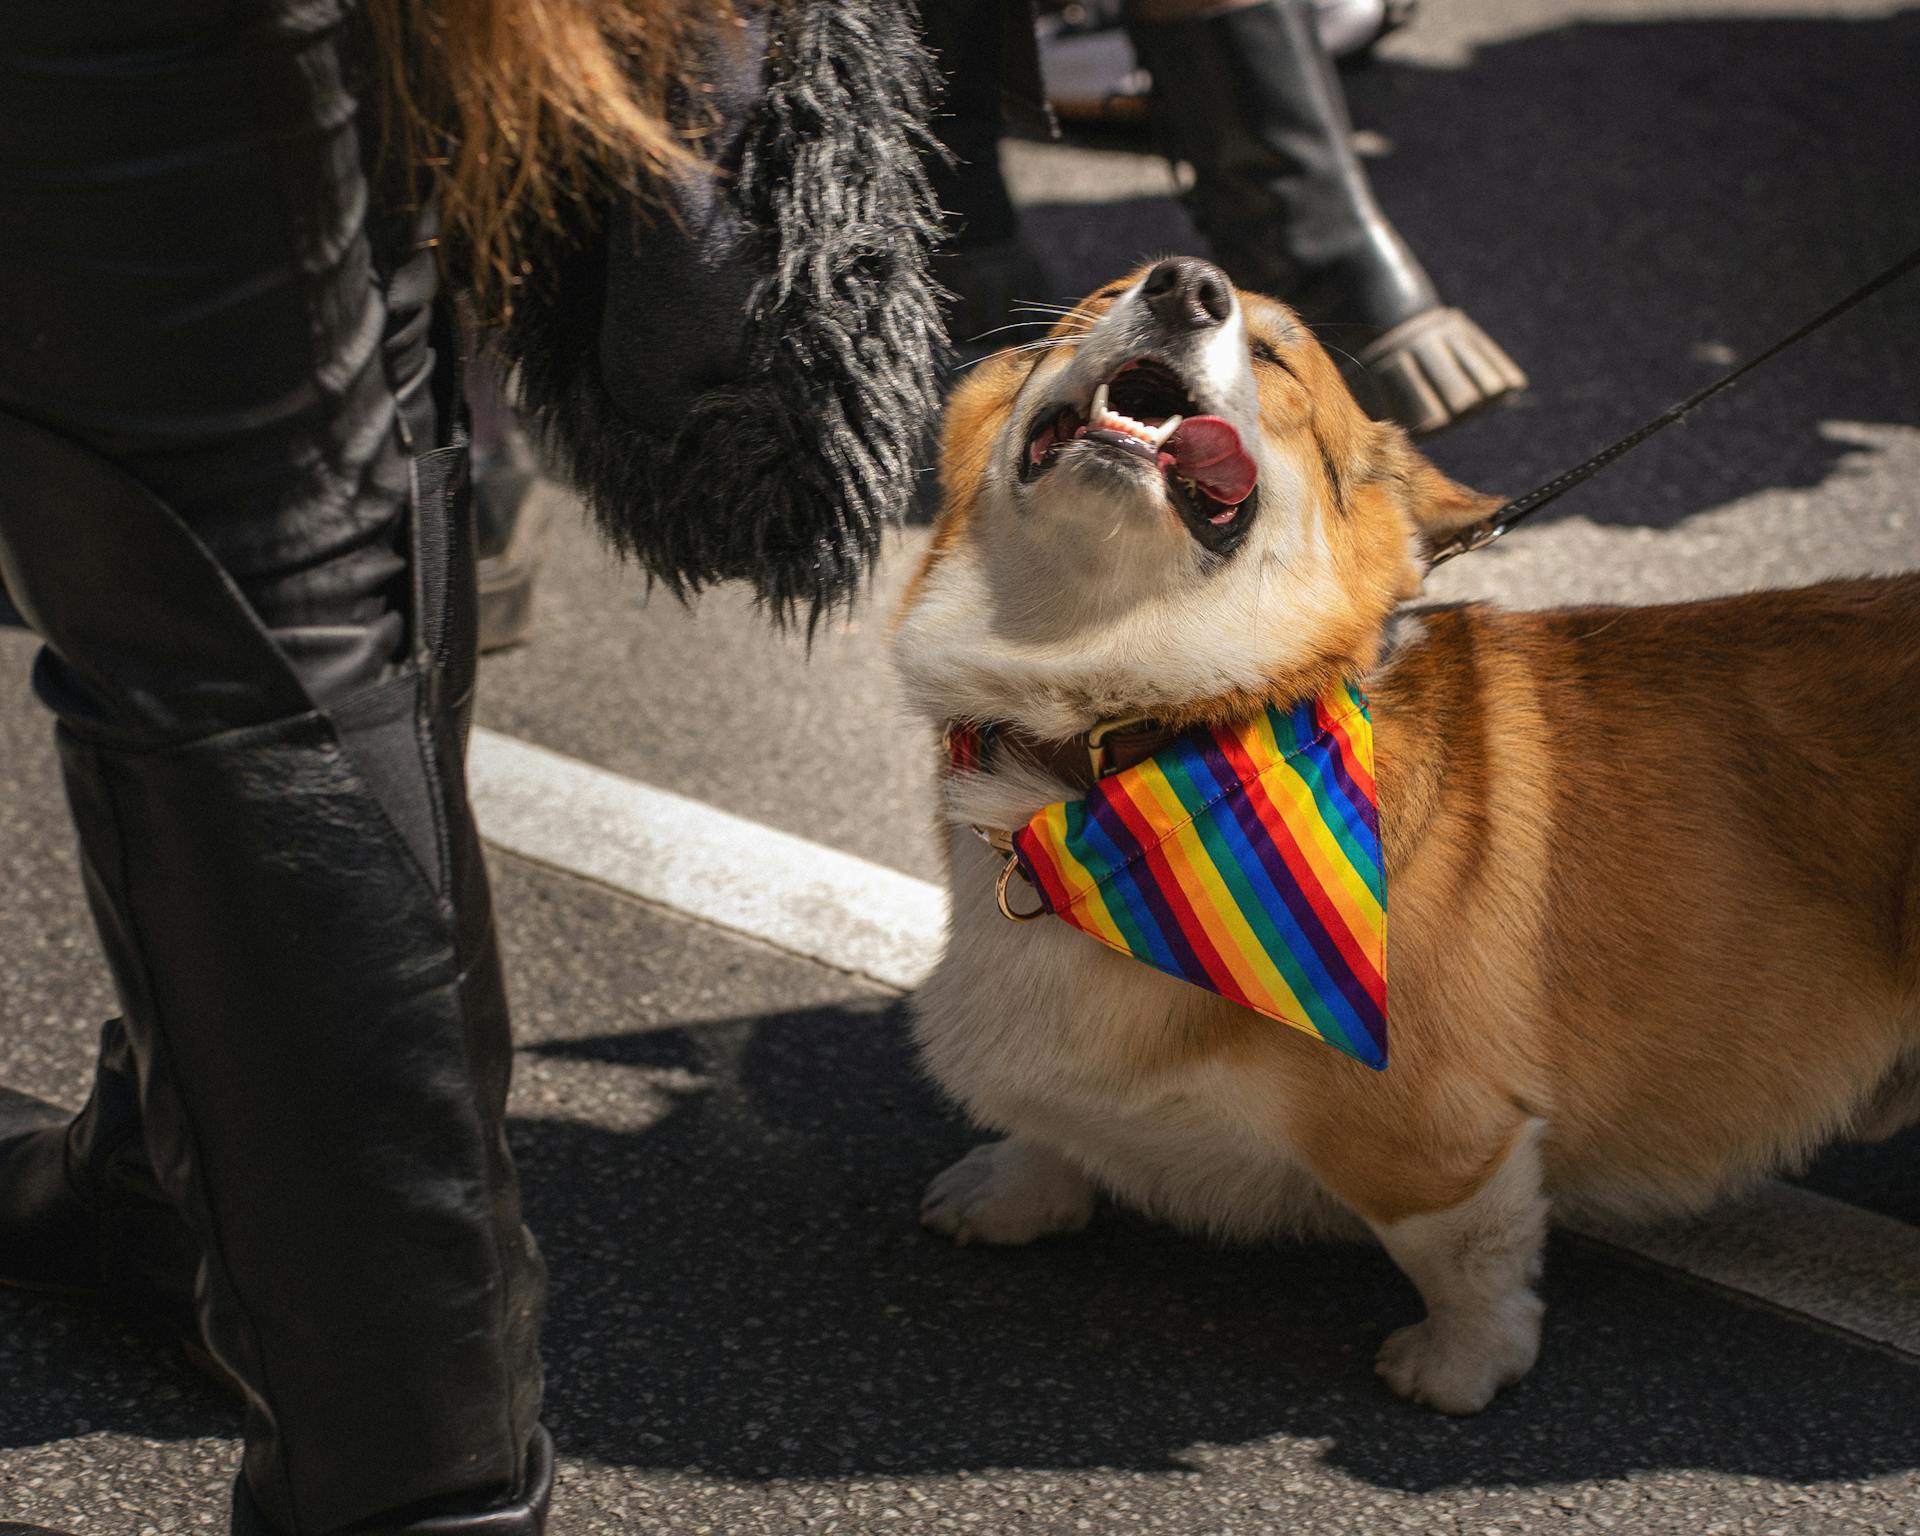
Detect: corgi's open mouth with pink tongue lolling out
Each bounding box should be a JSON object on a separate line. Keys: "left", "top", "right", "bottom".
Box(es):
{"left": 1020, "top": 357, "right": 1260, "bottom": 549}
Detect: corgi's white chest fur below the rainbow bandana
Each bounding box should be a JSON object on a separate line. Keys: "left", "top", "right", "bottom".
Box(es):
{"left": 914, "top": 772, "right": 1357, "bottom": 1236}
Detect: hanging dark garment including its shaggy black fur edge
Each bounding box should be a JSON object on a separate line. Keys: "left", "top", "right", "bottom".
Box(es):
{"left": 503, "top": 0, "right": 945, "bottom": 624}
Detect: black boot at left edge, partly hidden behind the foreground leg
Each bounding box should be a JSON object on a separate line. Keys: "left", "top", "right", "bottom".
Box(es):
{"left": 0, "top": 1020, "right": 200, "bottom": 1338}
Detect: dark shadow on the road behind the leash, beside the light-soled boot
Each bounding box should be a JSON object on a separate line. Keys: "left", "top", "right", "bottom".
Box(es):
{"left": 1025, "top": 10, "right": 1920, "bottom": 528}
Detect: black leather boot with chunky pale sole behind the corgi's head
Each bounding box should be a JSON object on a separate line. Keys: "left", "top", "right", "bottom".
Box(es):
{"left": 1131, "top": 0, "right": 1526, "bottom": 432}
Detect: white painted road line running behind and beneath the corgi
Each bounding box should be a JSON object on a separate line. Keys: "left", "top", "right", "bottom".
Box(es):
{"left": 467, "top": 730, "right": 1920, "bottom": 1359}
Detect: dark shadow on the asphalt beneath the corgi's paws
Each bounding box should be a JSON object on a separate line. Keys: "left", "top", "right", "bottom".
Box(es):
{"left": 515, "top": 1008, "right": 1920, "bottom": 1490}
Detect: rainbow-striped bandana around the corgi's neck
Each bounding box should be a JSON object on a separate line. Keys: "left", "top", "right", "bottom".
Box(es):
{"left": 954, "top": 685, "right": 1386, "bottom": 1069}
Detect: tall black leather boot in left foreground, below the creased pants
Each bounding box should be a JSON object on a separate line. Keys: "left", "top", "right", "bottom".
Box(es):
{"left": 0, "top": 415, "right": 551, "bottom": 1536}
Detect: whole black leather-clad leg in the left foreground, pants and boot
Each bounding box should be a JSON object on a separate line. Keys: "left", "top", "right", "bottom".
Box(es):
{"left": 0, "top": 0, "right": 551, "bottom": 1536}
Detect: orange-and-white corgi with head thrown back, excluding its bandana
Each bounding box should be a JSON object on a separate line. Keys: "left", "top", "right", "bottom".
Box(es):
{"left": 895, "top": 257, "right": 1920, "bottom": 1413}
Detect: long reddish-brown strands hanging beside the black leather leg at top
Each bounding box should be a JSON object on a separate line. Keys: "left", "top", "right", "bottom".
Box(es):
{"left": 369, "top": 0, "right": 739, "bottom": 317}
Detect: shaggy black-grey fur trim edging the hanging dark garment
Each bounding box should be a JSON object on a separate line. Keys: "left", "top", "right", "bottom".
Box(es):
{"left": 503, "top": 0, "right": 945, "bottom": 630}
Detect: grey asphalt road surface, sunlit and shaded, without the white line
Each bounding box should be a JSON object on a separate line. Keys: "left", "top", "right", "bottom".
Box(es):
{"left": 0, "top": 0, "right": 1920, "bottom": 1536}
